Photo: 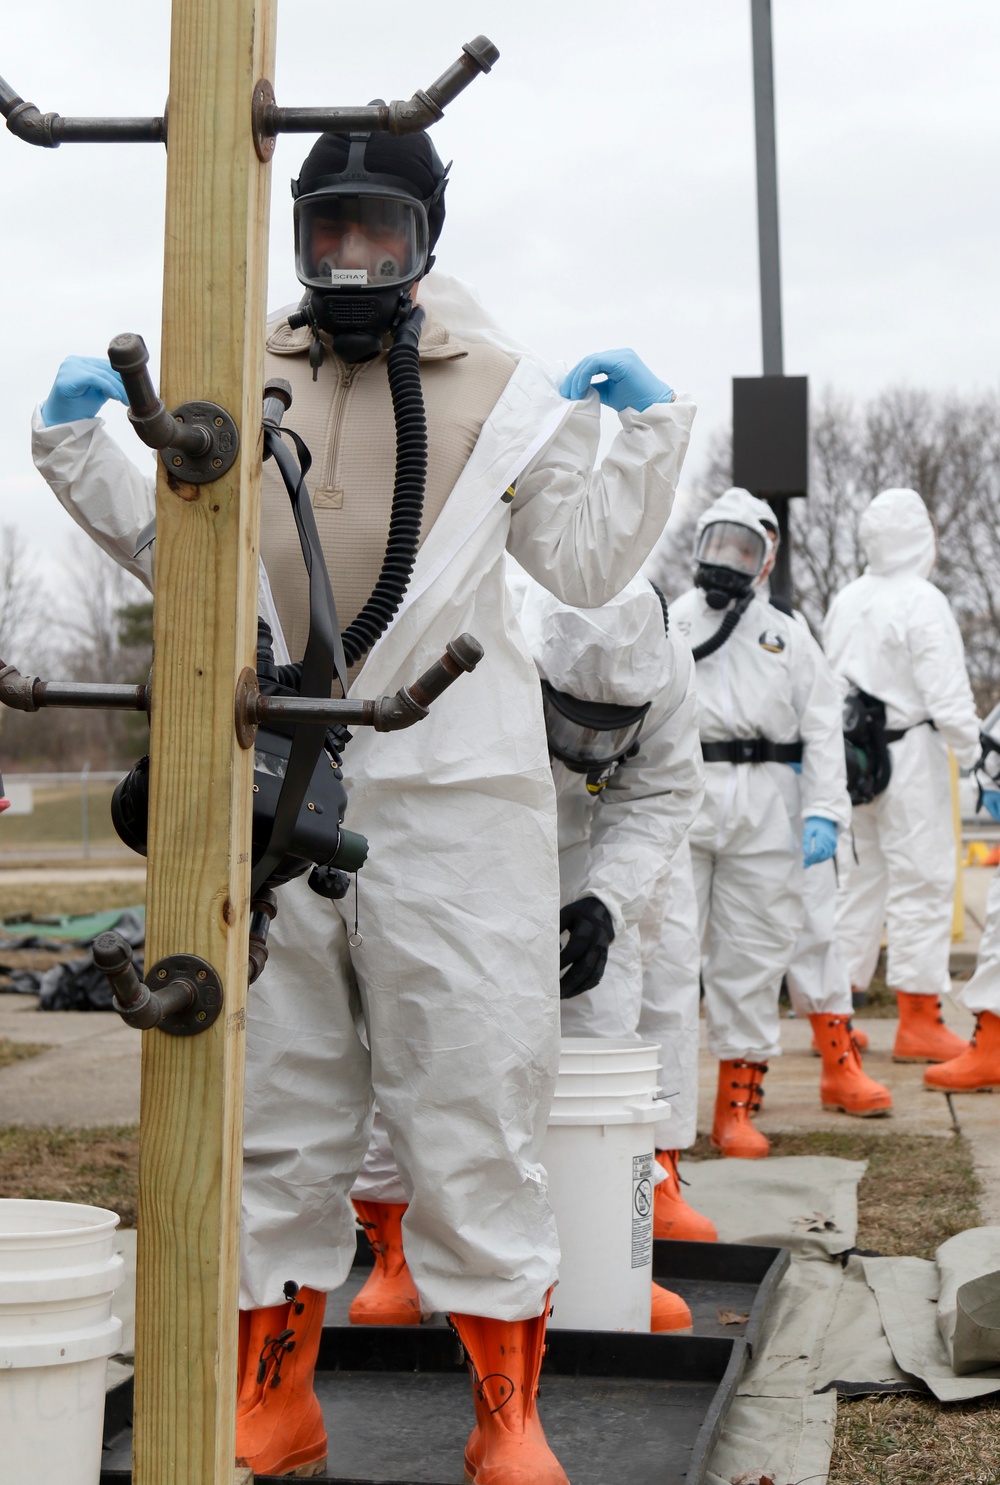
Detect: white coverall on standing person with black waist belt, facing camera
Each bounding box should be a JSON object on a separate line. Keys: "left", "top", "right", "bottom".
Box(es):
{"left": 670, "top": 490, "right": 850, "bottom": 1062}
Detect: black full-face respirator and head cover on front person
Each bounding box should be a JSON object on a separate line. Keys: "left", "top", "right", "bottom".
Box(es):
{"left": 288, "top": 124, "right": 450, "bottom": 376}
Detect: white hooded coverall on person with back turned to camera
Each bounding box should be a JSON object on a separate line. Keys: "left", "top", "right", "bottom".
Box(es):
{"left": 823, "top": 490, "right": 979, "bottom": 995}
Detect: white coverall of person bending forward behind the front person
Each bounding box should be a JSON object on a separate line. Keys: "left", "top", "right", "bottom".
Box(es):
{"left": 516, "top": 578, "right": 704, "bottom": 1116}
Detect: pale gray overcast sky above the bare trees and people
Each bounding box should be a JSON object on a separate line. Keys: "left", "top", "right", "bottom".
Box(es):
{"left": 0, "top": 0, "right": 1000, "bottom": 566}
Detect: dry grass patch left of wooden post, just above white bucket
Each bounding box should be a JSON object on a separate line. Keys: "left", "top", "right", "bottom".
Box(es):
{"left": 0, "top": 1126, "right": 138, "bottom": 1227}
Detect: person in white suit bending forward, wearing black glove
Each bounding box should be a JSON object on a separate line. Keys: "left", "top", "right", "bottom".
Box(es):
{"left": 516, "top": 578, "right": 716, "bottom": 1300}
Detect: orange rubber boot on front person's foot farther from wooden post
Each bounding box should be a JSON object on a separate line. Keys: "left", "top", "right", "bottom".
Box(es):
{"left": 449, "top": 1296, "right": 569, "bottom": 1485}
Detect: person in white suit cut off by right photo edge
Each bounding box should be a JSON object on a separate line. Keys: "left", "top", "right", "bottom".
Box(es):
{"left": 924, "top": 718, "right": 1000, "bottom": 1093}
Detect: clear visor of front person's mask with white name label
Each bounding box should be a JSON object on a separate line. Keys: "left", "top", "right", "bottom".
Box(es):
{"left": 294, "top": 192, "right": 428, "bottom": 290}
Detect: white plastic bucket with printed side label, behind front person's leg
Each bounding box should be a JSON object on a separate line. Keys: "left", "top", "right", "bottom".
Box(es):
{"left": 542, "top": 1037, "right": 670, "bottom": 1331}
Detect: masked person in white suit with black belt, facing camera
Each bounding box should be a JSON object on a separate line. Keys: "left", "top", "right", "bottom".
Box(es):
{"left": 670, "top": 490, "right": 871, "bottom": 1158}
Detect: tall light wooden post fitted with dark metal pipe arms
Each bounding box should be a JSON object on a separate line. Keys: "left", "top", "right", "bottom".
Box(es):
{"left": 132, "top": 0, "right": 276, "bottom": 1485}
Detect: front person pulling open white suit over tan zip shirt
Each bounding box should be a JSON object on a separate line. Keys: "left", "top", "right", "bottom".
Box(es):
{"left": 27, "top": 124, "right": 694, "bottom": 1485}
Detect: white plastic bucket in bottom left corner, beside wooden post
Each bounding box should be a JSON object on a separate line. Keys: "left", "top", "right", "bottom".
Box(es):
{"left": 0, "top": 1200, "right": 125, "bottom": 1485}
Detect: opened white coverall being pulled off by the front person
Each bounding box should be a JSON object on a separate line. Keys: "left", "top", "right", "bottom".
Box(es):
{"left": 34, "top": 276, "right": 694, "bottom": 1320}
